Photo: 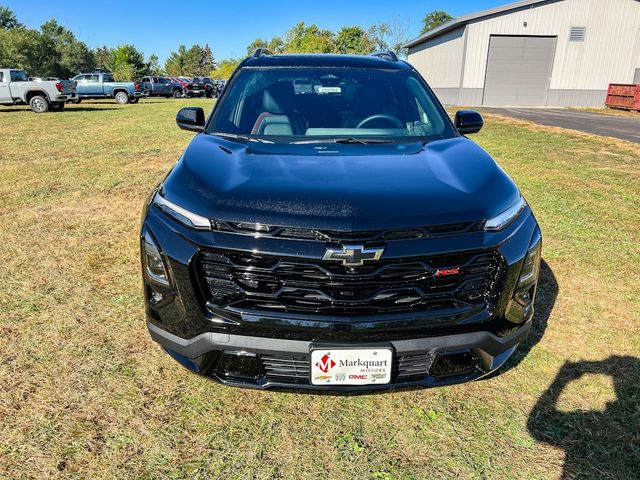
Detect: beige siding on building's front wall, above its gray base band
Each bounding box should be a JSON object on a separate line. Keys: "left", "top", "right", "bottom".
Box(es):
{"left": 462, "top": 0, "right": 640, "bottom": 90}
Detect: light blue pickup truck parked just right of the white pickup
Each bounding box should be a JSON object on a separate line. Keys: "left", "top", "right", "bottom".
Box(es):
{"left": 72, "top": 72, "right": 146, "bottom": 105}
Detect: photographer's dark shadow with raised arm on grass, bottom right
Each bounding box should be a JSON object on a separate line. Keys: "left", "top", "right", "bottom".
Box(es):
{"left": 527, "top": 356, "right": 640, "bottom": 479}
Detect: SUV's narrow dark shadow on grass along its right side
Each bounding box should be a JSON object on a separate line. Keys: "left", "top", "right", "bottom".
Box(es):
{"left": 496, "top": 259, "right": 559, "bottom": 378}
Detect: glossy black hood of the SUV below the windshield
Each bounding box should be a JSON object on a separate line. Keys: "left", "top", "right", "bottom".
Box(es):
{"left": 163, "top": 134, "right": 519, "bottom": 230}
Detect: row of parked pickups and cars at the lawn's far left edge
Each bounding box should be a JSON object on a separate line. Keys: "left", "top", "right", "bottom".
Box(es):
{"left": 0, "top": 68, "right": 225, "bottom": 113}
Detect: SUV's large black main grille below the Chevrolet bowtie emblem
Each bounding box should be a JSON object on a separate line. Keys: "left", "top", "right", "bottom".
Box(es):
{"left": 197, "top": 250, "right": 501, "bottom": 316}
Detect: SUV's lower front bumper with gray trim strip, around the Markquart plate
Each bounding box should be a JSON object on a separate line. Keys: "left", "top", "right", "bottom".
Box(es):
{"left": 147, "top": 321, "right": 531, "bottom": 391}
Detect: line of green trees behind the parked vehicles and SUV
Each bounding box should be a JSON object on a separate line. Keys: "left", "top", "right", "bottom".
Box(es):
{"left": 0, "top": 6, "right": 451, "bottom": 81}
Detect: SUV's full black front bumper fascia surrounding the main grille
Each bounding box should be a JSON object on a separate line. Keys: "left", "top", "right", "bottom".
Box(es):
{"left": 143, "top": 194, "right": 540, "bottom": 391}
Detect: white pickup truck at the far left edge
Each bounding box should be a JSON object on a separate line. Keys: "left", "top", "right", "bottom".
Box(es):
{"left": 0, "top": 68, "right": 77, "bottom": 113}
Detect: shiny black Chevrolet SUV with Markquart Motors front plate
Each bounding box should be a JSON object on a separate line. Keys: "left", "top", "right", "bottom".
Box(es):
{"left": 140, "top": 50, "right": 541, "bottom": 391}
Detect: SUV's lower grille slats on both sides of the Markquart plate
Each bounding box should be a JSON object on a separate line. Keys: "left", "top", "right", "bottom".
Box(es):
{"left": 261, "top": 353, "right": 436, "bottom": 385}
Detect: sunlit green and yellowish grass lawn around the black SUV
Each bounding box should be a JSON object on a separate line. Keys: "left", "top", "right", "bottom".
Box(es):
{"left": 0, "top": 99, "right": 640, "bottom": 479}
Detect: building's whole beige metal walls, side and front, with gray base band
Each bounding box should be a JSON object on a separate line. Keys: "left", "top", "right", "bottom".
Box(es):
{"left": 409, "top": 0, "right": 640, "bottom": 106}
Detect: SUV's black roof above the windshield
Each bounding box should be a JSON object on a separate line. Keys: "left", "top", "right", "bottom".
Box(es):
{"left": 240, "top": 54, "right": 413, "bottom": 70}
